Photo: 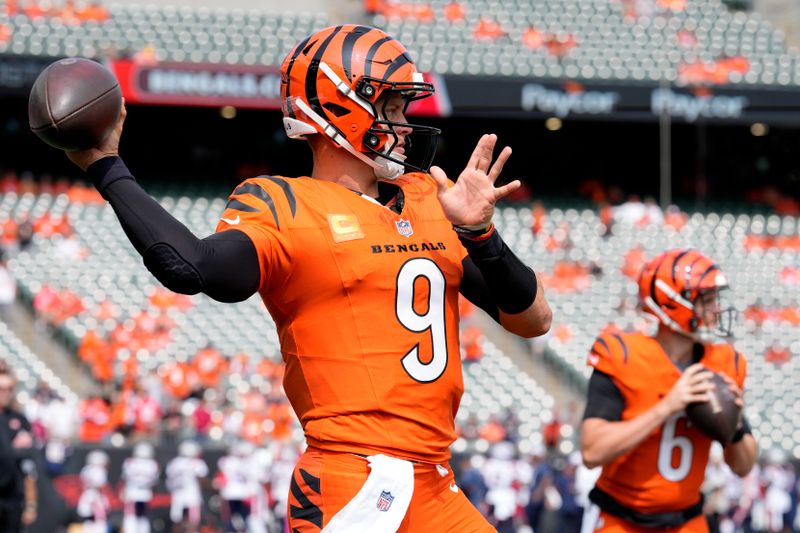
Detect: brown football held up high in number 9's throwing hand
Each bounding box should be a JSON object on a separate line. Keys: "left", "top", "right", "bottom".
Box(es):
{"left": 28, "top": 58, "right": 122, "bottom": 150}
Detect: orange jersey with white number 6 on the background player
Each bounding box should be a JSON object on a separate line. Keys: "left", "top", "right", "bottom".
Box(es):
{"left": 589, "top": 332, "right": 747, "bottom": 513}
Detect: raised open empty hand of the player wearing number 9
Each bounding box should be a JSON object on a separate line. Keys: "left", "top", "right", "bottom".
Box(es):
{"left": 430, "top": 133, "right": 521, "bottom": 226}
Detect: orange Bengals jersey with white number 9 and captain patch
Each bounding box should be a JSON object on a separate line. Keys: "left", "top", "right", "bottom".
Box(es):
{"left": 217, "top": 174, "right": 466, "bottom": 463}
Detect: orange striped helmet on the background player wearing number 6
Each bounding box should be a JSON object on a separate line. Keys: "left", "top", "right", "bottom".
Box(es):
{"left": 639, "top": 249, "right": 736, "bottom": 343}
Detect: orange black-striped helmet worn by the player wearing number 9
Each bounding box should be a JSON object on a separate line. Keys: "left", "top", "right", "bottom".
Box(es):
{"left": 281, "top": 24, "right": 441, "bottom": 179}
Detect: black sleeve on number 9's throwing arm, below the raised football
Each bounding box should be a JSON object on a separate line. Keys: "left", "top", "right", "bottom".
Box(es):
{"left": 86, "top": 157, "right": 261, "bottom": 302}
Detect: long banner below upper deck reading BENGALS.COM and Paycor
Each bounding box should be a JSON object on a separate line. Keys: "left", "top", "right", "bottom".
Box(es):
{"left": 6, "top": 55, "right": 800, "bottom": 126}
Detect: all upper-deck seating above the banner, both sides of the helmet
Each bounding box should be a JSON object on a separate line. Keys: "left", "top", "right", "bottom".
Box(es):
{"left": 0, "top": 0, "right": 800, "bottom": 86}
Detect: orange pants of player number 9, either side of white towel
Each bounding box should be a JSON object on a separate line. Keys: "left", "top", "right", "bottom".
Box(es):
{"left": 286, "top": 448, "right": 496, "bottom": 533}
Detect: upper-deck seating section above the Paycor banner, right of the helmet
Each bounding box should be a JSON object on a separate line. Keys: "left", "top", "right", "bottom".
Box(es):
{"left": 372, "top": 0, "right": 800, "bottom": 85}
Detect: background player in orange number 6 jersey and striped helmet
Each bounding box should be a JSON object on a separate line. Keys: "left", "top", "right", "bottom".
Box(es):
{"left": 581, "top": 249, "right": 757, "bottom": 533}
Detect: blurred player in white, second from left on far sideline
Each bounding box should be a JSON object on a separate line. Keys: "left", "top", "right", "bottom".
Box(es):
{"left": 122, "top": 442, "right": 158, "bottom": 533}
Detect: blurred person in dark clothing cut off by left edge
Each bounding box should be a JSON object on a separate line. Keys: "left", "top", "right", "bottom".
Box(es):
{"left": 0, "top": 361, "right": 37, "bottom": 533}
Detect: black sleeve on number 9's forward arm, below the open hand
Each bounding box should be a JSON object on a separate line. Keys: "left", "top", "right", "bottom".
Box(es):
{"left": 458, "top": 230, "right": 538, "bottom": 315}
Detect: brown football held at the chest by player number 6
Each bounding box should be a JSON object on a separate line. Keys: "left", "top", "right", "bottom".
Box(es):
{"left": 686, "top": 372, "right": 740, "bottom": 444}
